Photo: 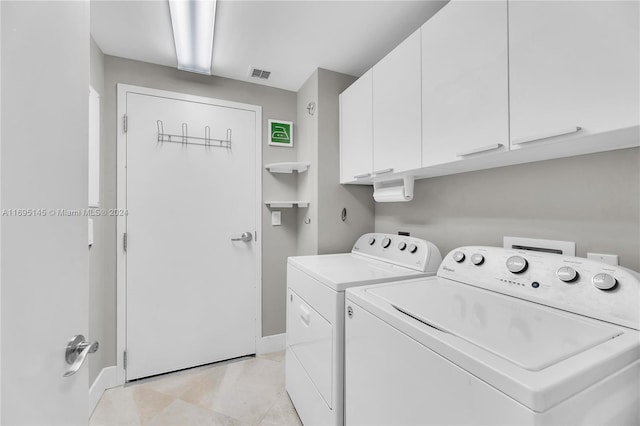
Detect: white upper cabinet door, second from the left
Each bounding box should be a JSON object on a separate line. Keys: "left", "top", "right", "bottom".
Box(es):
{"left": 373, "top": 30, "right": 422, "bottom": 175}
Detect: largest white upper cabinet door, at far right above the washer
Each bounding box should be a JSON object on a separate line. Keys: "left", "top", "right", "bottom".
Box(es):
{"left": 509, "top": 1, "right": 640, "bottom": 149}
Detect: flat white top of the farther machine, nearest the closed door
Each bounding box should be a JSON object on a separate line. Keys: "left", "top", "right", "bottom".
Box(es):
{"left": 288, "top": 253, "right": 434, "bottom": 291}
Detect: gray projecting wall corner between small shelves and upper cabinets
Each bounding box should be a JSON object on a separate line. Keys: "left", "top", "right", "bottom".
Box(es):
{"left": 296, "top": 69, "right": 374, "bottom": 256}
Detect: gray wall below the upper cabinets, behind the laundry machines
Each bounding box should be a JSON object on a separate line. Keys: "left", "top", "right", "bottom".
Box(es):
{"left": 375, "top": 148, "right": 640, "bottom": 270}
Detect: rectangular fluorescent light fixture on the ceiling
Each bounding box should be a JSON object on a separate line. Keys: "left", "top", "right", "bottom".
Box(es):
{"left": 169, "top": 0, "right": 216, "bottom": 75}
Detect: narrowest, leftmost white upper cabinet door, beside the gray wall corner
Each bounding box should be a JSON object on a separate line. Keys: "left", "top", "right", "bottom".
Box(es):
{"left": 340, "top": 70, "right": 373, "bottom": 183}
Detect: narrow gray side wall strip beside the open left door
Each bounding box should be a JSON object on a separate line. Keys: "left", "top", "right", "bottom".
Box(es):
{"left": 88, "top": 38, "right": 109, "bottom": 383}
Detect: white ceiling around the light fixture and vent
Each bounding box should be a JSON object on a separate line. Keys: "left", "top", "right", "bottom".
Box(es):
{"left": 91, "top": 0, "right": 446, "bottom": 91}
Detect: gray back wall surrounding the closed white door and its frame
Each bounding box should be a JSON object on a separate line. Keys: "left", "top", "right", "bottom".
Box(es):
{"left": 91, "top": 55, "right": 297, "bottom": 372}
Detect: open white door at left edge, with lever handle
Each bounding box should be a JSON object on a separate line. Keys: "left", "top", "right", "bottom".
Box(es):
{"left": 0, "top": 1, "right": 91, "bottom": 426}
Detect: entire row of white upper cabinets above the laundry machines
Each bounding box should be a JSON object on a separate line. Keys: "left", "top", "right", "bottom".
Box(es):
{"left": 341, "top": 0, "right": 640, "bottom": 184}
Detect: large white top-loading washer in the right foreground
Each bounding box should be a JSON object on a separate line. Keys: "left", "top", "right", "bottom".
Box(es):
{"left": 345, "top": 247, "right": 640, "bottom": 426}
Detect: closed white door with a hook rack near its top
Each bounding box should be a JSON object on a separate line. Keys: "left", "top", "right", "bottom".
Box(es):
{"left": 126, "top": 92, "right": 260, "bottom": 380}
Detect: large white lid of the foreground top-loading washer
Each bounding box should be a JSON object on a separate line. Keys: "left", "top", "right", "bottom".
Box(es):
{"left": 368, "top": 280, "right": 622, "bottom": 371}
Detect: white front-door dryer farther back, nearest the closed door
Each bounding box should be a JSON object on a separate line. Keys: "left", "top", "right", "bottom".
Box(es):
{"left": 286, "top": 233, "right": 442, "bottom": 425}
